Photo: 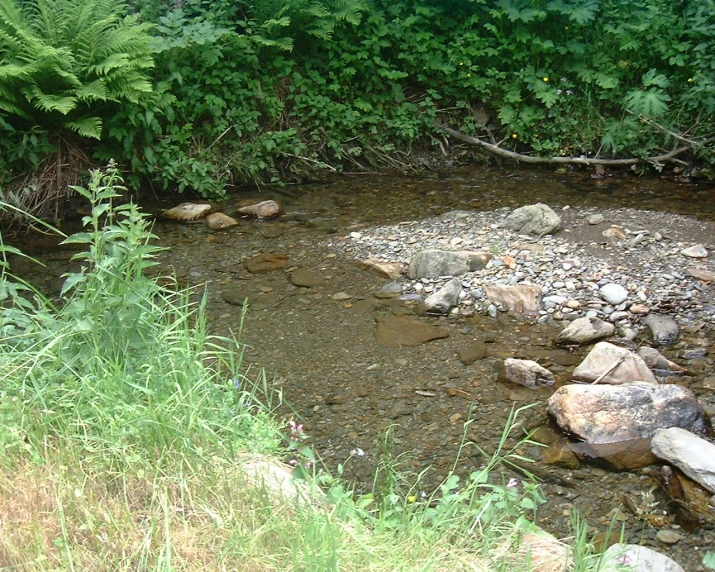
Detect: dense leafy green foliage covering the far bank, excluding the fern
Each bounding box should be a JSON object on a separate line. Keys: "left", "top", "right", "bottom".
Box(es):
{"left": 0, "top": 0, "right": 715, "bottom": 206}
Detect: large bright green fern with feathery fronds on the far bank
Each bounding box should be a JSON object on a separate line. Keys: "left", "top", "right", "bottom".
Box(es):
{"left": 0, "top": 0, "right": 153, "bottom": 139}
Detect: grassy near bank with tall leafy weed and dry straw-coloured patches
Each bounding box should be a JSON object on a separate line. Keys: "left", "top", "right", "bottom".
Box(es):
{"left": 0, "top": 165, "right": 608, "bottom": 571}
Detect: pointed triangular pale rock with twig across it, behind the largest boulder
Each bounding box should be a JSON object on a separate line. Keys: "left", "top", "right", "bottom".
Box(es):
{"left": 572, "top": 342, "right": 658, "bottom": 385}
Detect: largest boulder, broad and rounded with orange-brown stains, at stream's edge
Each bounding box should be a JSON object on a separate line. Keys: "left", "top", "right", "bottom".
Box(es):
{"left": 548, "top": 382, "right": 707, "bottom": 443}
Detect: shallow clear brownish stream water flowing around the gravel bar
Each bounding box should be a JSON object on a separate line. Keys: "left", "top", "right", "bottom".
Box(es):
{"left": 9, "top": 168, "right": 715, "bottom": 570}
